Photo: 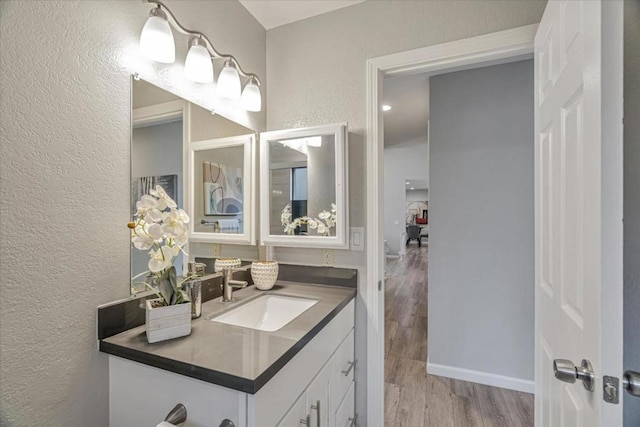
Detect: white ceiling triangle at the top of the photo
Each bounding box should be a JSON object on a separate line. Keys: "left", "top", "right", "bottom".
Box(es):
{"left": 240, "top": 0, "right": 365, "bottom": 30}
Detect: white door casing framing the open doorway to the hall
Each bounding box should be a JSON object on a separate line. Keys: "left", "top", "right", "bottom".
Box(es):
{"left": 360, "top": 24, "right": 538, "bottom": 427}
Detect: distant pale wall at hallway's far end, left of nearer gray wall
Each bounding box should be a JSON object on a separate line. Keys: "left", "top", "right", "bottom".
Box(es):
{"left": 384, "top": 141, "right": 429, "bottom": 255}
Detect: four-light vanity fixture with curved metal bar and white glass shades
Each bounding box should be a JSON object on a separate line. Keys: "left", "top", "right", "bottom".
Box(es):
{"left": 140, "top": 0, "right": 262, "bottom": 112}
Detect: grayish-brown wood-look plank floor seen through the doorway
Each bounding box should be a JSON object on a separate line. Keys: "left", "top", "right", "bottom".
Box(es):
{"left": 384, "top": 242, "right": 533, "bottom": 427}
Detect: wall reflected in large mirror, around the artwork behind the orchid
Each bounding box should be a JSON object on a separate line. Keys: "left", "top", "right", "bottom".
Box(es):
{"left": 131, "top": 120, "right": 184, "bottom": 280}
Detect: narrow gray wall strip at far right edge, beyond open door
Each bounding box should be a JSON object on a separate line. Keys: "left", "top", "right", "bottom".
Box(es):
{"left": 624, "top": 0, "right": 640, "bottom": 427}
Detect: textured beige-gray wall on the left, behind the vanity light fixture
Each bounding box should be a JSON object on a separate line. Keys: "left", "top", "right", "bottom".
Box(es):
{"left": 0, "top": 0, "right": 266, "bottom": 427}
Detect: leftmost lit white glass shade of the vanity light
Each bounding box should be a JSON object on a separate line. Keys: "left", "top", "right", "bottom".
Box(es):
{"left": 140, "top": 7, "right": 176, "bottom": 64}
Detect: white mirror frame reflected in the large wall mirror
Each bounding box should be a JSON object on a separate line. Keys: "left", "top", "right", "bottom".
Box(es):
{"left": 185, "top": 134, "right": 256, "bottom": 245}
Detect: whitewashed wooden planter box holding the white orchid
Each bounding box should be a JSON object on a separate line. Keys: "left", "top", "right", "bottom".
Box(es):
{"left": 146, "top": 299, "right": 191, "bottom": 343}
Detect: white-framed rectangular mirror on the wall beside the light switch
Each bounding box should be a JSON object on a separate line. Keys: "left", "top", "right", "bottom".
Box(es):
{"left": 260, "top": 123, "right": 349, "bottom": 249}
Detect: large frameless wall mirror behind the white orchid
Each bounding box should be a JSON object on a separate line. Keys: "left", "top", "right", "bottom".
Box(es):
{"left": 131, "top": 78, "right": 257, "bottom": 292}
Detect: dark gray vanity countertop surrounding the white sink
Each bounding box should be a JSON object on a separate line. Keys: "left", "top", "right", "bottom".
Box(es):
{"left": 100, "top": 281, "right": 356, "bottom": 394}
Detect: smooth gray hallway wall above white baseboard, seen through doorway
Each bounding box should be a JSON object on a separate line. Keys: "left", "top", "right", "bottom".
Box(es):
{"left": 428, "top": 60, "right": 535, "bottom": 381}
